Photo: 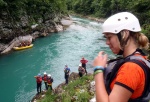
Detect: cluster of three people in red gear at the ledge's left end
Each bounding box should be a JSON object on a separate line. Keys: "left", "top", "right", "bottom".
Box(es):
{"left": 34, "top": 72, "right": 53, "bottom": 94}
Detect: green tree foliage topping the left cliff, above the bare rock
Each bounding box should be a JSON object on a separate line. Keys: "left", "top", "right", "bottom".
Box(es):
{"left": 0, "top": 0, "right": 66, "bottom": 24}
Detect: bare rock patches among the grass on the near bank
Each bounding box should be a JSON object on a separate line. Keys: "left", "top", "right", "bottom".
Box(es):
{"left": 31, "top": 72, "right": 96, "bottom": 102}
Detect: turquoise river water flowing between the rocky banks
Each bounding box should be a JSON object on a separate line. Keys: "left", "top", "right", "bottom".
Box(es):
{"left": 0, "top": 17, "right": 114, "bottom": 102}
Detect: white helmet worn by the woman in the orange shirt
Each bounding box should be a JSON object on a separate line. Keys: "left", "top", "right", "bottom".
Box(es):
{"left": 102, "top": 12, "right": 141, "bottom": 34}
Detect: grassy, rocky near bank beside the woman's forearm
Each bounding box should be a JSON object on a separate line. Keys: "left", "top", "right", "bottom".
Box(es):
{"left": 31, "top": 72, "right": 95, "bottom": 102}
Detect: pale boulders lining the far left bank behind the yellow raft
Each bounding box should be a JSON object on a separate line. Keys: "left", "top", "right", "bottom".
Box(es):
{"left": 0, "top": 17, "right": 73, "bottom": 54}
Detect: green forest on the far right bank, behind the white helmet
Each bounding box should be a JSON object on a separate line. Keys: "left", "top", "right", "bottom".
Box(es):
{"left": 67, "top": 0, "right": 150, "bottom": 39}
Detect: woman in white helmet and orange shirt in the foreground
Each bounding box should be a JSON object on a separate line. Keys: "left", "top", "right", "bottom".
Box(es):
{"left": 93, "top": 12, "right": 149, "bottom": 102}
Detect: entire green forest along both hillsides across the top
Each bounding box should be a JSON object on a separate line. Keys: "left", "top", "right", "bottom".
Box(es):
{"left": 0, "top": 0, "right": 150, "bottom": 42}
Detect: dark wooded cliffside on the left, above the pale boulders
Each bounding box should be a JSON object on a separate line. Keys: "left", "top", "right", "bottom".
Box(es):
{"left": 0, "top": 0, "right": 67, "bottom": 43}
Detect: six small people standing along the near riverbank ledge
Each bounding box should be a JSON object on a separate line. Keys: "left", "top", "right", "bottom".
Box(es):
{"left": 34, "top": 57, "right": 88, "bottom": 94}
